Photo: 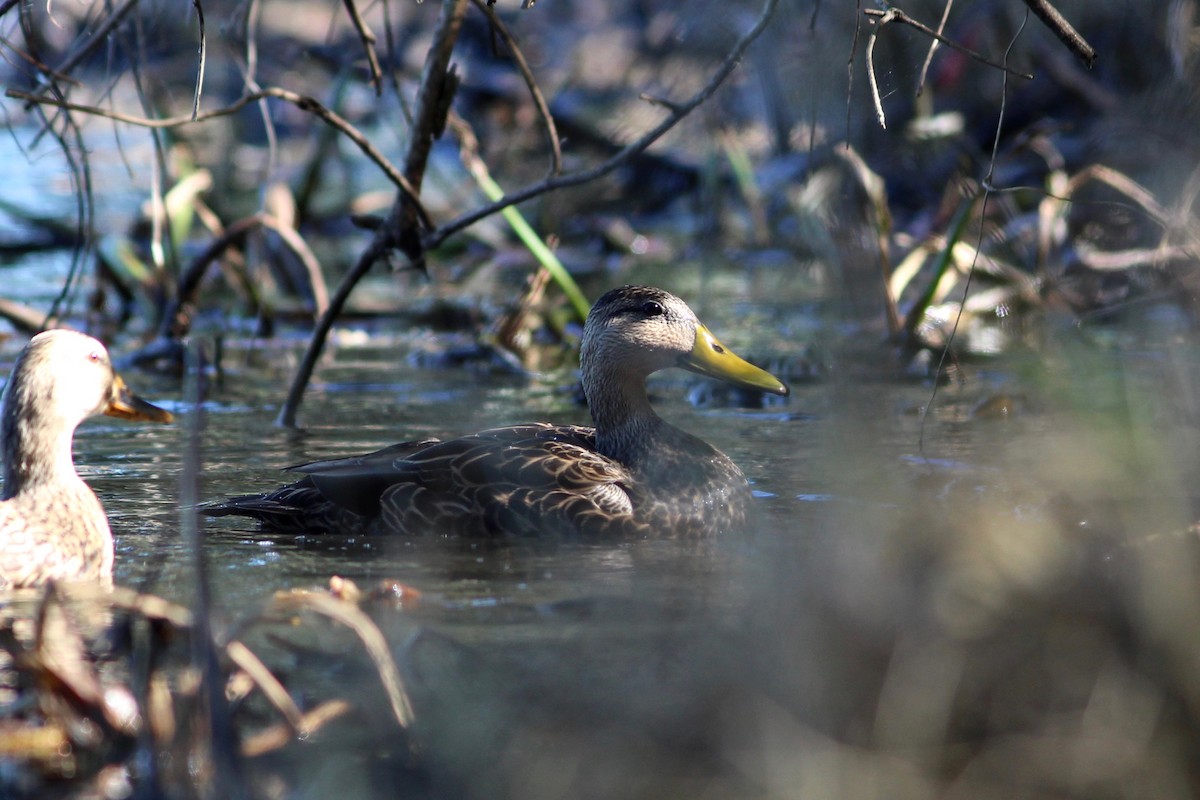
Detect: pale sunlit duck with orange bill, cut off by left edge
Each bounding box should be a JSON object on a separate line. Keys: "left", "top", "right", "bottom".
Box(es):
{"left": 0, "top": 329, "right": 173, "bottom": 590}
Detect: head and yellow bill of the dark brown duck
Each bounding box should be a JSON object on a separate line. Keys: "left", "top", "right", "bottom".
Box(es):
{"left": 580, "top": 285, "right": 788, "bottom": 399}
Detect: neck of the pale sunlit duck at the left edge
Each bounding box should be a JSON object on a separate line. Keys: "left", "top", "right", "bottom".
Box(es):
{"left": 0, "top": 397, "right": 79, "bottom": 500}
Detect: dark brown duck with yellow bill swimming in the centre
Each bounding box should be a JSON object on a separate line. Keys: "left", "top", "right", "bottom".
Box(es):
{"left": 204, "top": 285, "right": 788, "bottom": 540}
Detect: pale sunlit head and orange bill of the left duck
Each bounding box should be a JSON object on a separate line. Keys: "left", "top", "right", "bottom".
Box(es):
{"left": 5, "top": 330, "right": 173, "bottom": 429}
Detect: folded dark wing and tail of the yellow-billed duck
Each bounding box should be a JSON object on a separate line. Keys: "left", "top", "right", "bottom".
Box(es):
{"left": 204, "top": 423, "right": 635, "bottom": 536}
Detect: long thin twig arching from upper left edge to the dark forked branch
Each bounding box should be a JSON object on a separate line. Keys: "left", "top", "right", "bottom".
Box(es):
{"left": 5, "top": 86, "right": 432, "bottom": 227}
